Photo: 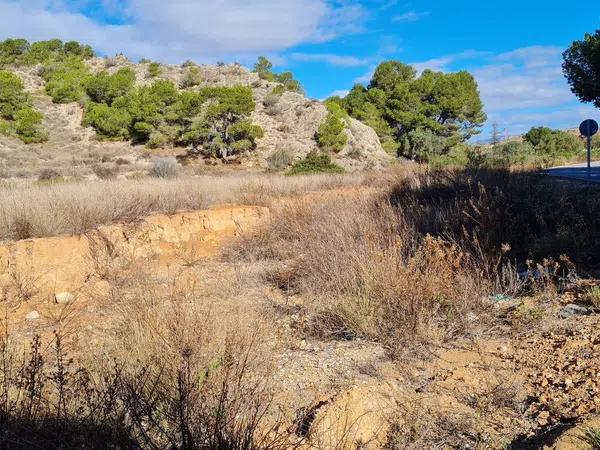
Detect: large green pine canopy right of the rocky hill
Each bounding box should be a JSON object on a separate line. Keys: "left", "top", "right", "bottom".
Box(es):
{"left": 331, "top": 61, "right": 486, "bottom": 157}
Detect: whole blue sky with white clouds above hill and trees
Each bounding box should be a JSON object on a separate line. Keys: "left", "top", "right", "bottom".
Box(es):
{"left": 0, "top": 0, "right": 600, "bottom": 138}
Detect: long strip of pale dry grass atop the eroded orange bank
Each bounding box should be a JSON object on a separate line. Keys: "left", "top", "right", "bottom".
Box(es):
{"left": 0, "top": 175, "right": 363, "bottom": 240}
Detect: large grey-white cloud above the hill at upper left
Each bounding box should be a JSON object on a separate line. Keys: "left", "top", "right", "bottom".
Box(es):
{"left": 0, "top": 0, "right": 364, "bottom": 62}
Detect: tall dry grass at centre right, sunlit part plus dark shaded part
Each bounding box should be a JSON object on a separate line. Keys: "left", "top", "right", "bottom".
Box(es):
{"left": 233, "top": 166, "right": 600, "bottom": 353}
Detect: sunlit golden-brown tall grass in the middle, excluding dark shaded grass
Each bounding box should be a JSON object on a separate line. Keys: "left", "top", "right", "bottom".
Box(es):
{"left": 232, "top": 193, "right": 491, "bottom": 351}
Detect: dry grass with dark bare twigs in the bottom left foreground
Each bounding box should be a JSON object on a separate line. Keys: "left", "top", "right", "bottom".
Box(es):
{"left": 0, "top": 262, "right": 296, "bottom": 450}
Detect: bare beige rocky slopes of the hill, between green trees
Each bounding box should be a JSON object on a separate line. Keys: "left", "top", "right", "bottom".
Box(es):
{"left": 0, "top": 56, "right": 390, "bottom": 179}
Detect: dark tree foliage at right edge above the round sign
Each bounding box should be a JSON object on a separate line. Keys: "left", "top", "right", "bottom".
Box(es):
{"left": 562, "top": 29, "right": 600, "bottom": 108}
